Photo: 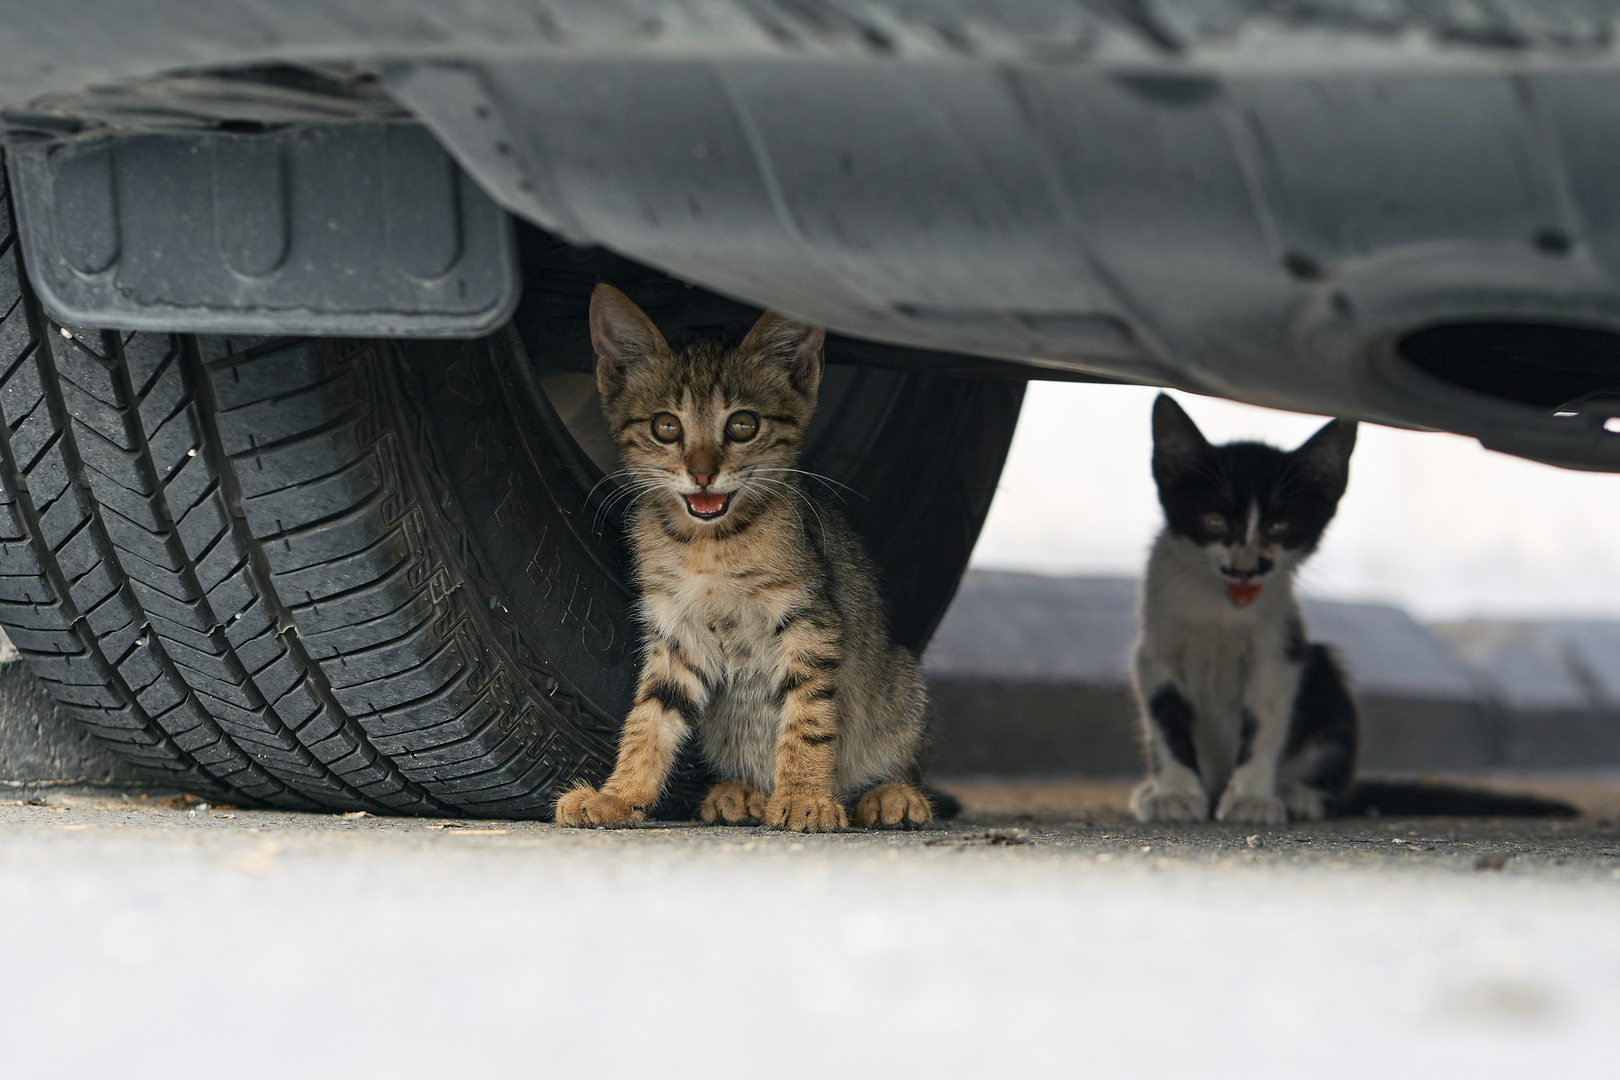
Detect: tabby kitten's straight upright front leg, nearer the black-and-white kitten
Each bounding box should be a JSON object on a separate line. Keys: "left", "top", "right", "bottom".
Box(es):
{"left": 765, "top": 631, "right": 849, "bottom": 832}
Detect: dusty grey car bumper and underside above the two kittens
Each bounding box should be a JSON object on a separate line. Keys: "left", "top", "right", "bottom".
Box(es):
{"left": 9, "top": 0, "right": 1620, "bottom": 470}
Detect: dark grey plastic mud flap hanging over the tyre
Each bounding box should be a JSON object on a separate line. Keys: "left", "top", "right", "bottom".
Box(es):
{"left": 6, "top": 121, "right": 522, "bottom": 337}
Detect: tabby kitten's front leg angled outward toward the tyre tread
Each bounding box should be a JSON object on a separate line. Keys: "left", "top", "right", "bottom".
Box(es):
{"left": 556, "top": 638, "right": 708, "bottom": 826}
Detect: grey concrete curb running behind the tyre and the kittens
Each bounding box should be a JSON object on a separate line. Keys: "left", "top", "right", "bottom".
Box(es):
{"left": 0, "top": 572, "right": 1620, "bottom": 792}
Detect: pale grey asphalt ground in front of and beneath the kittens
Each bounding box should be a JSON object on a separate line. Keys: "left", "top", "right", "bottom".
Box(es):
{"left": 0, "top": 776, "right": 1620, "bottom": 1078}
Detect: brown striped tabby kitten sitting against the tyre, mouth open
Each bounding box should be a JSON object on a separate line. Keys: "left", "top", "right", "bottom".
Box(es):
{"left": 556, "top": 285, "right": 933, "bottom": 832}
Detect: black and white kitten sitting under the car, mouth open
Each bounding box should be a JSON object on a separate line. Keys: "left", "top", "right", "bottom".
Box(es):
{"left": 1131, "top": 393, "right": 1356, "bottom": 824}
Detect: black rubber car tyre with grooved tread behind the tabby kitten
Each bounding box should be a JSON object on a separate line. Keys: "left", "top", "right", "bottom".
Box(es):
{"left": 0, "top": 186, "right": 1022, "bottom": 816}
